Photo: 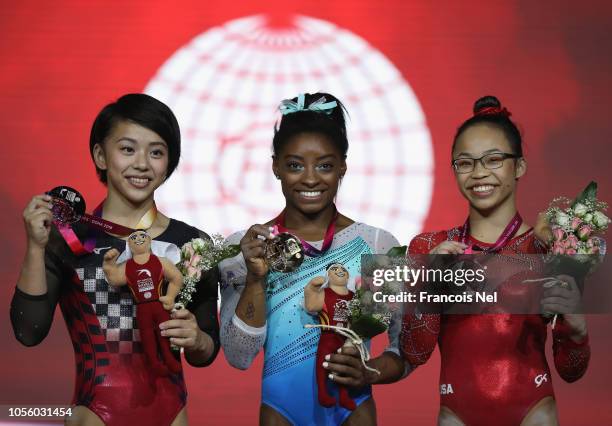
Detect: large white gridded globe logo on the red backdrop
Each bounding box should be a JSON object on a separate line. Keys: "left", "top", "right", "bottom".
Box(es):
{"left": 145, "top": 15, "right": 433, "bottom": 242}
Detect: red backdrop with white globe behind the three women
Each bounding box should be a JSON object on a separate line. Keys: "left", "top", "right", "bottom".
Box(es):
{"left": 0, "top": 0, "right": 612, "bottom": 425}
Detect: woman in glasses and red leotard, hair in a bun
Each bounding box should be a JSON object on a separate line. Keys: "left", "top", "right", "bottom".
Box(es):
{"left": 401, "top": 96, "right": 590, "bottom": 426}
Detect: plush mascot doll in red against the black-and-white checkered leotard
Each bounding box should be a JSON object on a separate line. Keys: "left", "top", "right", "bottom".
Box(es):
{"left": 102, "top": 230, "right": 183, "bottom": 376}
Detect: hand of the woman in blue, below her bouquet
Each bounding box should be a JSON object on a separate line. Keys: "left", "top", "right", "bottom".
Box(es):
{"left": 323, "top": 347, "right": 372, "bottom": 388}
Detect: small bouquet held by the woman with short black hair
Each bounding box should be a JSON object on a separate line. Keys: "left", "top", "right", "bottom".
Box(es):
{"left": 177, "top": 234, "right": 240, "bottom": 306}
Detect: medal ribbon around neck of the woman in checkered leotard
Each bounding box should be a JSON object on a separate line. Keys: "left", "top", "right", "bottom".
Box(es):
{"left": 53, "top": 201, "right": 157, "bottom": 256}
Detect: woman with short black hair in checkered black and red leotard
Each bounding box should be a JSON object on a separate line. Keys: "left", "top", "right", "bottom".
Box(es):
{"left": 11, "top": 94, "right": 219, "bottom": 426}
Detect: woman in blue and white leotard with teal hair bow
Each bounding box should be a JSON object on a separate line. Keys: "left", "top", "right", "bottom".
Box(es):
{"left": 219, "top": 93, "right": 408, "bottom": 426}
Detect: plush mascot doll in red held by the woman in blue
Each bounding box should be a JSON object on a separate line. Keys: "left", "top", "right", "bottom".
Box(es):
{"left": 304, "top": 263, "right": 356, "bottom": 410}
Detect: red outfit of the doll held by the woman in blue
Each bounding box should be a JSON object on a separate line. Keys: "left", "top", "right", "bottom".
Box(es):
{"left": 315, "top": 288, "right": 357, "bottom": 410}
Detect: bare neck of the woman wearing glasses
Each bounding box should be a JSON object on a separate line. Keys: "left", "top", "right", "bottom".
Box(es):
{"left": 468, "top": 197, "right": 524, "bottom": 243}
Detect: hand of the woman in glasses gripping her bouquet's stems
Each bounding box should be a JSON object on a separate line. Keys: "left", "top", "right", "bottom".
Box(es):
{"left": 540, "top": 275, "right": 587, "bottom": 340}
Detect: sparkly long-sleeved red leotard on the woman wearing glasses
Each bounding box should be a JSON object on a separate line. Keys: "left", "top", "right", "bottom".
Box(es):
{"left": 401, "top": 228, "right": 590, "bottom": 426}
